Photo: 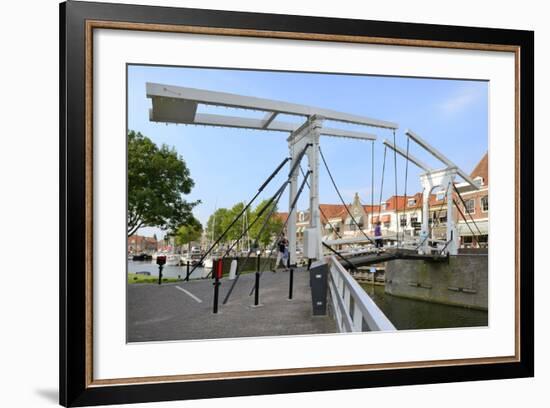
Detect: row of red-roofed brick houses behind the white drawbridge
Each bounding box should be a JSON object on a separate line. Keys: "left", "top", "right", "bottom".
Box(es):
{"left": 286, "top": 154, "right": 489, "bottom": 248}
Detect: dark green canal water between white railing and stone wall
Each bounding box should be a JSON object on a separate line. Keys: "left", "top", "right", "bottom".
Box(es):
{"left": 361, "top": 284, "right": 488, "bottom": 330}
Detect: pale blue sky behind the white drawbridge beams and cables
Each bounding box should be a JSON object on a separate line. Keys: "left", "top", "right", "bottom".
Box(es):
{"left": 128, "top": 65, "right": 489, "bottom": 235}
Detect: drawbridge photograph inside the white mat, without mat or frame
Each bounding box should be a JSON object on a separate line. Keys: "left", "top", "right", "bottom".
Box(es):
{"left": 126, "top": 63, "right": 492, "bottom": 343}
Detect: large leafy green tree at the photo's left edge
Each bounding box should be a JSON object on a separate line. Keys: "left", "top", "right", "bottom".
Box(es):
{"left": 127, "top": 131, "right": 200, "bottom": 236}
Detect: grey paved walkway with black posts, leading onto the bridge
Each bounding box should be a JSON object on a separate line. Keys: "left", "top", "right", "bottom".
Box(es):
{"left": 127, "top": 269, "right": 336, "bottom": 342}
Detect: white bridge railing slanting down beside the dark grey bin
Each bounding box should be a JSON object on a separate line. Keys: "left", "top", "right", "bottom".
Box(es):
{"left": 328, "top": 256, "right": 396, "bottom": 333}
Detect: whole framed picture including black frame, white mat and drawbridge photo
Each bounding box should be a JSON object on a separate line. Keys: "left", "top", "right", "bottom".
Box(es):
{"left": 55, "top": 1, "right": 535, "bottom": 406}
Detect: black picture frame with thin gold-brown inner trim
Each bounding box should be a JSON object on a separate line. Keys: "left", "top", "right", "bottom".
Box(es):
{"left": 59, "top": 1, "right": 534, "bottom": 406}
